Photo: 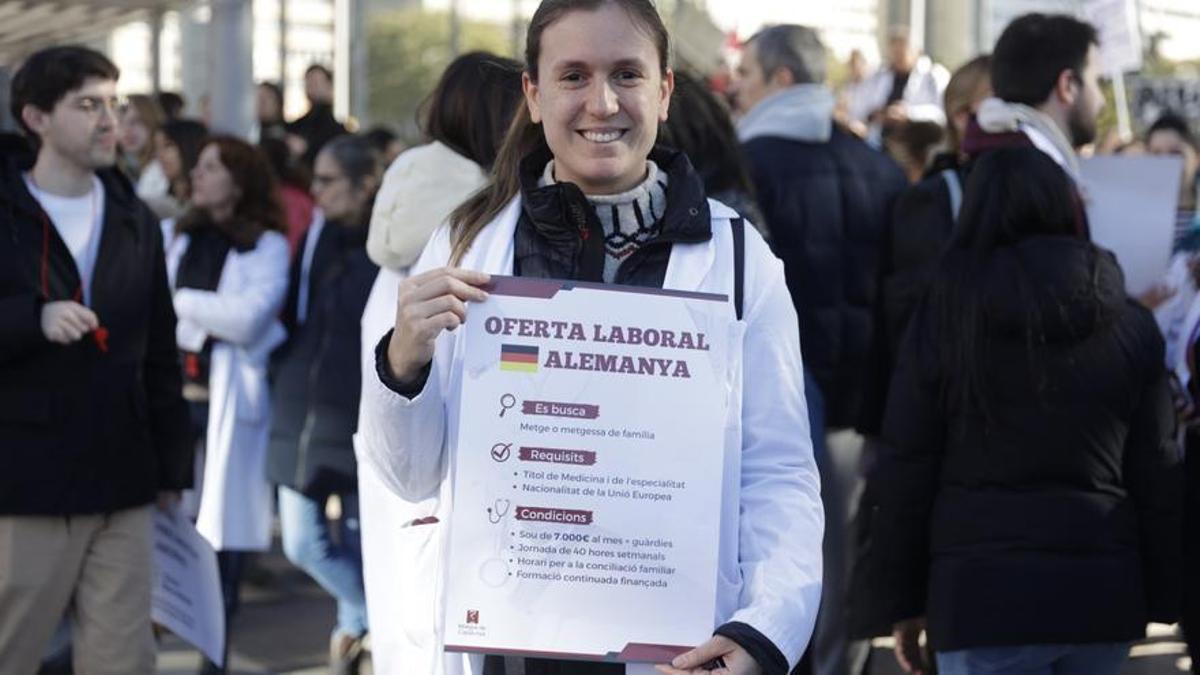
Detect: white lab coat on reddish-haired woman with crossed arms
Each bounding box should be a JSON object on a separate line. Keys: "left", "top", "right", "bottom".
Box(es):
{"left": 163, "top": 221, "right": 290, "bottom": 551}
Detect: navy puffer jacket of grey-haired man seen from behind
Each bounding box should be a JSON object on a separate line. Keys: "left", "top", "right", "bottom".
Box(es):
{"left": 743, "top": 127, "right": 907, "bottom": 428}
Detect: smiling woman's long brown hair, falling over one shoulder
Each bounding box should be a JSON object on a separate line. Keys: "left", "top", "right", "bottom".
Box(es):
{"left": 450, "top": 0, "right": 670, "bottom": 264}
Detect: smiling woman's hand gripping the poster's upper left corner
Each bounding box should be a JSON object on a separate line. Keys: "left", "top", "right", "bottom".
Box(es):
{"left": 388, "top": 267, "right": 491, "bottom": 383}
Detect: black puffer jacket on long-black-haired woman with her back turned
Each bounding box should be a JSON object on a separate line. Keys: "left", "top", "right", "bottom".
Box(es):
{"left": 851, "top": 237, "right": 1183, "bottom": 651}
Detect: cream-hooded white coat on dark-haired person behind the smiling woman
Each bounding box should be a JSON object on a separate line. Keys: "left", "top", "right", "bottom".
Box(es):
{"left": 355, "top": 142, "right": 487, "bottom": 675}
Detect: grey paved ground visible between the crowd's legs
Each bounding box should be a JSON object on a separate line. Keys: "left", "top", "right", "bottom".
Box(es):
{"left": 158, "top": 542, "right": 1189, "bottom": 675}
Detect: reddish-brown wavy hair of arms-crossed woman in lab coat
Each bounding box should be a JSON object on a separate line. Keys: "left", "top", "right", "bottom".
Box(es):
{"left": 175, "top": 136, "right": 287, "bottom": 246}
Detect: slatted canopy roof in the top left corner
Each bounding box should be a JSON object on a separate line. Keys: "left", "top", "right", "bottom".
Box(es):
{"left": 0, "top": 0, "right": 180, "bottom": 65}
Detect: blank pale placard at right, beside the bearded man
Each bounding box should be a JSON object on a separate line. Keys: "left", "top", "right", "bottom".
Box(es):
{"left": 1082, "top": 156, "right": 1183, "bottom": 295}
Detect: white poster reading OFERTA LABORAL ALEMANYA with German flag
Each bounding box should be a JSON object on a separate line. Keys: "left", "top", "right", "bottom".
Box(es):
{"left": 444, "top": 276, "right": 733, "bottom": 663}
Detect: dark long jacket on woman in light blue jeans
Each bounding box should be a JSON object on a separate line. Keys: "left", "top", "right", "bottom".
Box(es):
{"left": 266, "top": 218, "right": 379, "bottom": 500}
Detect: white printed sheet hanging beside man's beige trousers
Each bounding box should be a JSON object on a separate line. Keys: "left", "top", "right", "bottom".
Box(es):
{"left": 150, "top": 512, "right": 226, "bottom": 665}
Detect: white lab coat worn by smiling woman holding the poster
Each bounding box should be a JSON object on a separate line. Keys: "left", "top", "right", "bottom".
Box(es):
{"left": 358, "top": 198, "right": 824, "bottom": 674}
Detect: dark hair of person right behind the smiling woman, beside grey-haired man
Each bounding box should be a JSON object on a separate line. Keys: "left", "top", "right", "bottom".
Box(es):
{"left": 662, "top": 71, "right": 763, "bottom": 228}
